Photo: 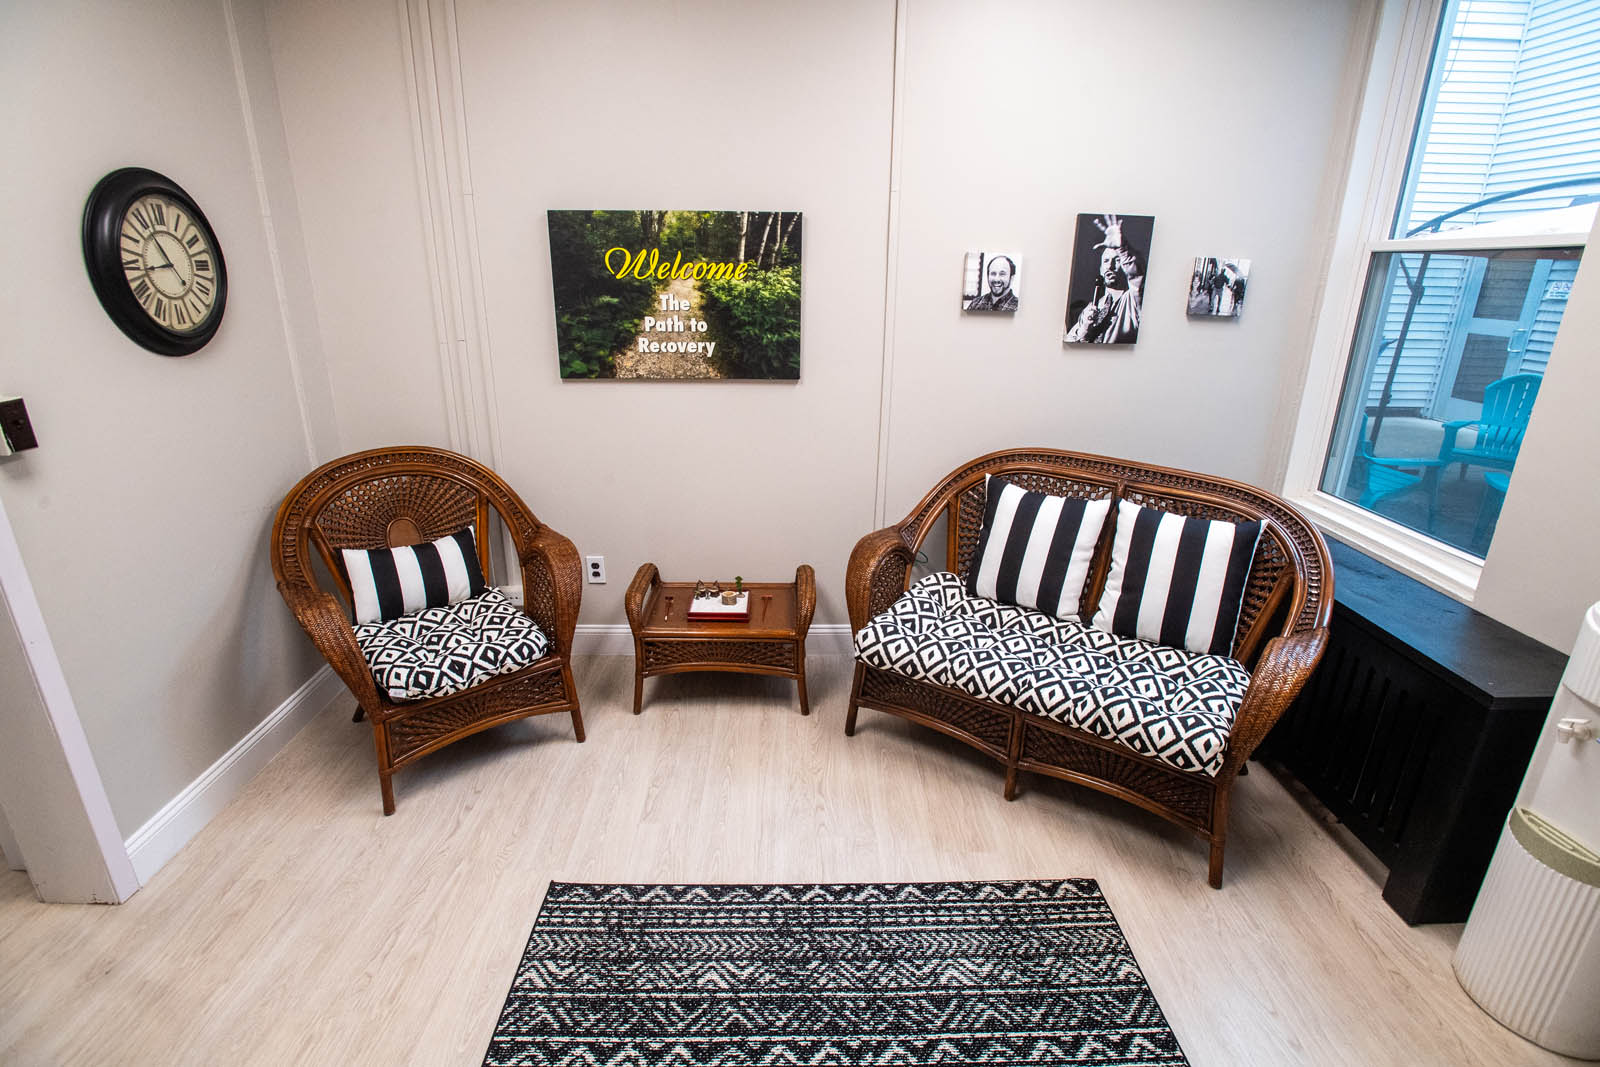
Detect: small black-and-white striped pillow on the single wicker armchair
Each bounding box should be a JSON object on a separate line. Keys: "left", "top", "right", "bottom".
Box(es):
{"left": 342, "top": 526, "right": 486, "bottom": 622}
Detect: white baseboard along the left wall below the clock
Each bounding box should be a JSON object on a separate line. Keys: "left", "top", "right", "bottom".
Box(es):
{"left": 126, "top": 667, "right": 346, "bottom": 886}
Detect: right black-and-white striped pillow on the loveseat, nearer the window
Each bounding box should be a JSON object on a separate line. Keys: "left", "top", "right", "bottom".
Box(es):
{"left": 1091, "top": 501, "right": 1261, "bottom": 656}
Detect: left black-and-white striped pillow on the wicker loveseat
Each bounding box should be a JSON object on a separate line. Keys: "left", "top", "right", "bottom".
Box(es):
{"left": 966, "top": 477, "right": 1110, "bottom": 619}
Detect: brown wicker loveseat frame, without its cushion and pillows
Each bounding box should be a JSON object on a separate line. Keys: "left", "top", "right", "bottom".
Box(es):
{"left": 845, "top": 450, "right": 1333, "bottom": 888}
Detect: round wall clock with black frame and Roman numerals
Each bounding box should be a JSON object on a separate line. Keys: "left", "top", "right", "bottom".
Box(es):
{"left": 83, "top": 166, "right": 227, "bottom": 355}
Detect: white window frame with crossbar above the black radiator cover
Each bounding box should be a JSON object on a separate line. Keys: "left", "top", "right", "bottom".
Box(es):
{"left": 1283, "top": 0, "right": 1589, "bottom": 603}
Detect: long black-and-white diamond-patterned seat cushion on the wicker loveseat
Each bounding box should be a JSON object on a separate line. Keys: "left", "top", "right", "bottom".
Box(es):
{"left": 856, "top": 571, "right": 1250, "bottom": 774}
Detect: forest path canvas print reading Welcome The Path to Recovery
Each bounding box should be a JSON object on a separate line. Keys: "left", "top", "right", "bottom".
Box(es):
{"left": 549, "top": 211, "right": 802, "bottom": 381}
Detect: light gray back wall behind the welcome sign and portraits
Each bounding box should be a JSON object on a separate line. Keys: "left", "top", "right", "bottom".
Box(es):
{"left": 269, "top": 0, "right": 1366, "bottom": 625}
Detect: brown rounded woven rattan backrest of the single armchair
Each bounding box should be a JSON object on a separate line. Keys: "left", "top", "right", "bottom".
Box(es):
{"left": 272, "top": 446, "right": 538, "bottom": 605}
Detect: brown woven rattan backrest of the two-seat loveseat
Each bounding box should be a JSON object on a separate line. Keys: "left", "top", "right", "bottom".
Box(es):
{"left": 901, "top": 450, "right": 1333, "bottom": 662}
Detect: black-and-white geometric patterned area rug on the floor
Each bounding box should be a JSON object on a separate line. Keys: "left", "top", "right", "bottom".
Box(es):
{"left": 483, "top": 878, "right": 1187, "bottom": 1067}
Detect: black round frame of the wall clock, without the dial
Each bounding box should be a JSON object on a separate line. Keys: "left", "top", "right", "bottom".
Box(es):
{"left": 83, "top": 166, "right": 227, "bottom": 355}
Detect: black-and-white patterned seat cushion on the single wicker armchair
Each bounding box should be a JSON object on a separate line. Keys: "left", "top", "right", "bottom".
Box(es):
{"left": 355, "top": 589, "right": 550, "bottom": 702}
